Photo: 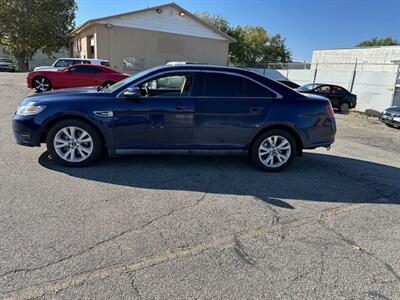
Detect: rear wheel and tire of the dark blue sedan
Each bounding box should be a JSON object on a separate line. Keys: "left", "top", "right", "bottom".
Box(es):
{"left": 251, "top": 129, "right": 297, "bottom": 172}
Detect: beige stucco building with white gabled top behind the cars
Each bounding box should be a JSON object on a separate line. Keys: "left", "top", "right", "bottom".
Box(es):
{"left": 72, "top": 3, "right": 235, "bottom": 73}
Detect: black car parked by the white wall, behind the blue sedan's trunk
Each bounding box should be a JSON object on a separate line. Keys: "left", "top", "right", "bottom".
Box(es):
{"left": 297, "top": 83, "right": 357, "bottom": 114}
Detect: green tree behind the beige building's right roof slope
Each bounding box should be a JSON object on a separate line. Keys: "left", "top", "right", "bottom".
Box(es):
{"left": 197, "top": 12, "right": 292, "bottom": 66}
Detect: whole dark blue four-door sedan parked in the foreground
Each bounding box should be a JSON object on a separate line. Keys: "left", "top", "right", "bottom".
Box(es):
{"left": 13, "top": 65, "right": 336, "bottom": 171}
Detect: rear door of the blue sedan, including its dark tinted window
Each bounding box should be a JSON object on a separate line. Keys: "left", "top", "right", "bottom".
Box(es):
{"left": 192, "top": 72, "right": 275, "bottom": 149}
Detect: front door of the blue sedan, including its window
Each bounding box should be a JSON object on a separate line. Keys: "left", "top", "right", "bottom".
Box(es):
{"left": 114, "top": 73, "right": 196, "bottom": 149}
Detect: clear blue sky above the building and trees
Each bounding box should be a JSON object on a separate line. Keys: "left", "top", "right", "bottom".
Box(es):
{"left": 75, "top": 0, "right": 400, "bottom": 61}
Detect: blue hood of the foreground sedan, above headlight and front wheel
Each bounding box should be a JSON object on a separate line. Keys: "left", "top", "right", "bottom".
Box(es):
{"left": 21, "top": 86, "right": 99, "bottom": 104}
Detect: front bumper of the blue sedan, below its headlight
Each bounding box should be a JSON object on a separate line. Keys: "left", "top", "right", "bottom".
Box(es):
{"left": 12, "top": 115, "right": 40, "bottom": 147}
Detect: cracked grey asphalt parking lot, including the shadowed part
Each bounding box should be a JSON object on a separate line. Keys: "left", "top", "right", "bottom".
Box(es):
{"left": 0, "top": 73, "right": 400, "bottom": 299}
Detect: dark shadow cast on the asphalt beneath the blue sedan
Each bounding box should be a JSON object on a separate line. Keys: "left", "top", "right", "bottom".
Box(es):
{"left": 39, "top": 152, "right": 400, "bottom": 209}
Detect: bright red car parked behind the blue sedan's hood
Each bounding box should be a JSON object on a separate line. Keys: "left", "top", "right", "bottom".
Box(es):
{"left": 27, "top": 64, "right": 130, "bottom": 92}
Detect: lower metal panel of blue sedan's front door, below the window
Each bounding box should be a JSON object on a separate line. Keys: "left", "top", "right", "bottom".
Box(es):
{"left": 113, "top": 97, "right": 195, "bottom": 149}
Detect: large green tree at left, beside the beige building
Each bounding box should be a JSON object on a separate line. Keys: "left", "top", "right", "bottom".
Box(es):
{"left": 0, "top": 0, "right": 77, "bottom": 71}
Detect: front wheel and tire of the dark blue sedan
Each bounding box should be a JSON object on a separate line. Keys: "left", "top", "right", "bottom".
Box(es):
{"left": 46, "top": 119, "right": 104, "bottom": 167}
